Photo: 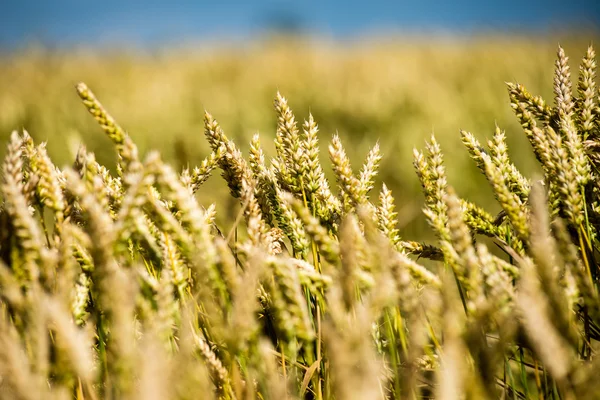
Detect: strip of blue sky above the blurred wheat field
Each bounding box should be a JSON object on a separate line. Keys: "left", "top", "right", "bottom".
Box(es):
{"left": 0, "top": 0, "right": 600, "bottom": 48}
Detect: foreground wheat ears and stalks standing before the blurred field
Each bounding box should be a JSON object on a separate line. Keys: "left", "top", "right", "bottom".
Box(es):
{"left": 0, "top": 47, "right": 600, "bottom": 399}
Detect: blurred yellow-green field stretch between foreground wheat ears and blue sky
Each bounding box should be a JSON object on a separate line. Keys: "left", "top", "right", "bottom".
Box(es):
{"left": 0, "top": 37, "right": 590, "bottom": 234}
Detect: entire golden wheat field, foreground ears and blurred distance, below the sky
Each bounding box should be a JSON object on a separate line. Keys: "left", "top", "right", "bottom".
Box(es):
{"left": 0, "top": 37, "right": 600, "bottom": 400}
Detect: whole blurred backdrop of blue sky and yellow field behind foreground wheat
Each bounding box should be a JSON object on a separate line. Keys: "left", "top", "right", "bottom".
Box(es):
{"left": 0, "top": 0, "right": 600, "bottom": 238}
